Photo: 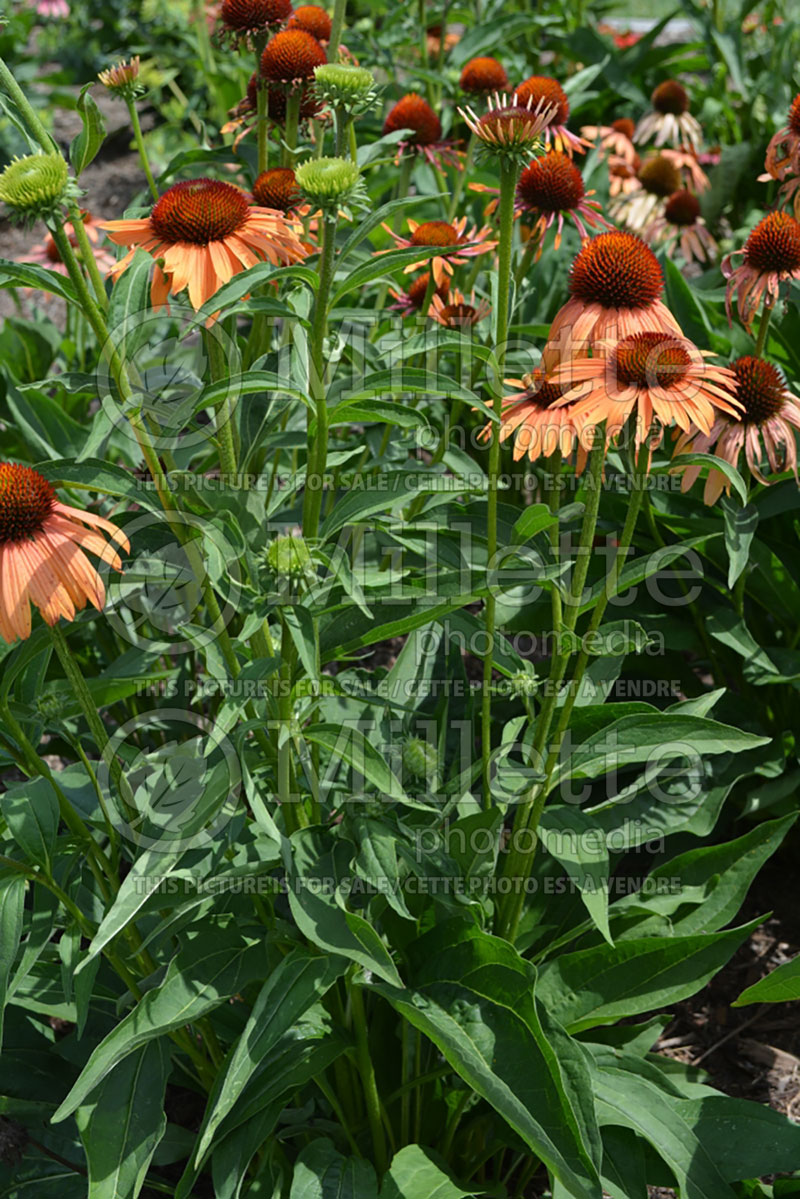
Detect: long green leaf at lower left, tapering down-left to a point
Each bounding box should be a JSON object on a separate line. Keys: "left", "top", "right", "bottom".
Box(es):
{"left": 53, "top": 927, "right": 266, "bottom": 1123}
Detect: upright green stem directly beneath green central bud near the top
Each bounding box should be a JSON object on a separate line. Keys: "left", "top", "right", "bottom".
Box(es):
{"left": 302, "top": 216, "right": 336, "bottom": 537}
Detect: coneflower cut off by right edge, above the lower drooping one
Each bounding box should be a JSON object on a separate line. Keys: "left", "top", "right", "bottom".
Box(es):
{"left": 722, "top": 212, "right": 800, "bottom": 329}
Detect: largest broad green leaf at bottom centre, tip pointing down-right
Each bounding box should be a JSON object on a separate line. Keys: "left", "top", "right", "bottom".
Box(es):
{"left": 374, "top": 921, "right": 601, "bottom": 1199}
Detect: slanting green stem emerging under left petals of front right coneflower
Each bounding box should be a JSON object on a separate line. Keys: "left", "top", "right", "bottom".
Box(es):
{"left": 497, "top": 426, "right": 606, "bottom": 941}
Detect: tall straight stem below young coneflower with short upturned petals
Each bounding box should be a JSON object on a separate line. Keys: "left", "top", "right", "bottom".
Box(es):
{"left": 482, "top": 159, "right": 519, "bottom": 808}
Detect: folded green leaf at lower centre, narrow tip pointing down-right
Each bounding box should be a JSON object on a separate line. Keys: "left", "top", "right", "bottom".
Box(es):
{"left": 284, "top": 829, "right": 401, "bottom": 984}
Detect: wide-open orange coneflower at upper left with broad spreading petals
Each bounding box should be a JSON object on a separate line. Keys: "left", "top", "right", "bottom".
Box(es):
{"left": 98, "top": 179, "right": 306, "bottom": 308}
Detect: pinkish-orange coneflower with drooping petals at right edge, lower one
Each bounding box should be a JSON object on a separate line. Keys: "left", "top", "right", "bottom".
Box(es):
{"left": 675, "top": 356, "right": 800, "bottom": 504}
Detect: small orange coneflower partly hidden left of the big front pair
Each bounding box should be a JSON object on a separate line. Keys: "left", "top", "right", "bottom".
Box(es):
{"left": 480, "top": 370, "right": 591, "bottom": 468}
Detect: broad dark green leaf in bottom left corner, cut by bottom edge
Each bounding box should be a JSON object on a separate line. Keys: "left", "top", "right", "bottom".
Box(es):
{"left": 76, "top": 1037, "right": 170, "bottom": 1199}
